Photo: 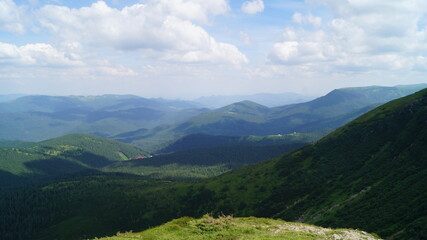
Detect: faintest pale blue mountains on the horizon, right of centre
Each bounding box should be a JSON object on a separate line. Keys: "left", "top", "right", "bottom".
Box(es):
{"left": 194, "top": 93, "right": 314, "bottom": 108}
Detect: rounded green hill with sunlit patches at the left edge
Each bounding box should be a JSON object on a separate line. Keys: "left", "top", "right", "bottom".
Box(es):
{"left": 0, "top": 134, "right": 147, "bottom": 186}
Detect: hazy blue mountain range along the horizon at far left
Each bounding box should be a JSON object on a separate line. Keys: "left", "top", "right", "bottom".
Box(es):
{"left": 0, "top": 95, "right": 207, "bottom": 141}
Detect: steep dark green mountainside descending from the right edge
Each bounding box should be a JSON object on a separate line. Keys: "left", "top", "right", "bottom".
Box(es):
{"left": 198, "top": 86, "right": 427, "bottom": 239}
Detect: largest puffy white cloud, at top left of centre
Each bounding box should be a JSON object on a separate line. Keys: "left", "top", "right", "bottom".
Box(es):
{"left": 38, "top": 0, "right": 247, "bottom": 64}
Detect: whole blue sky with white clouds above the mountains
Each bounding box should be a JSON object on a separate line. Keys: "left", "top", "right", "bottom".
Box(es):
{"left": 0, "top": 0, "right": 427, "bottom": 99}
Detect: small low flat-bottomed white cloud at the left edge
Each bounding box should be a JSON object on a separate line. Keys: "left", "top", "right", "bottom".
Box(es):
{"left": 0, "top": 42, "right": 83, "bottom": 67}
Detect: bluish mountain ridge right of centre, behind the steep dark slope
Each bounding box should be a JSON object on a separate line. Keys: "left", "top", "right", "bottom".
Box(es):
{"left": 116, "top": 84, "right": 427, "bottom": 150}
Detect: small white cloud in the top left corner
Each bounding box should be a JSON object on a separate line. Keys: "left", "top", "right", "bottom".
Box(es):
{"left": 0, "top": 0, "right": 25, "bottom": 33}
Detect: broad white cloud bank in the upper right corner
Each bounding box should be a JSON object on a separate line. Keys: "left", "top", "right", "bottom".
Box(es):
{"left": 269, "top": 0, "right": 427, "bottom": 72}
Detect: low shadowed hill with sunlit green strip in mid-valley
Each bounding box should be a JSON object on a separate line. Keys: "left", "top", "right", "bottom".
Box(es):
{"left": 100, "top": 142, "right": 306, "bottom": 180}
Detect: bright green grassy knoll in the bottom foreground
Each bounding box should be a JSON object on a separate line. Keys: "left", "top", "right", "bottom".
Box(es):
{"left": 95, "top": 215, "right": 379, "bottom": 240}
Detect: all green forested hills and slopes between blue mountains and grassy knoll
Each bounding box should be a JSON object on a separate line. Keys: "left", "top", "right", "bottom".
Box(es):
{"left": 0, "top": 87, "right": 427, "bottom": 239}
